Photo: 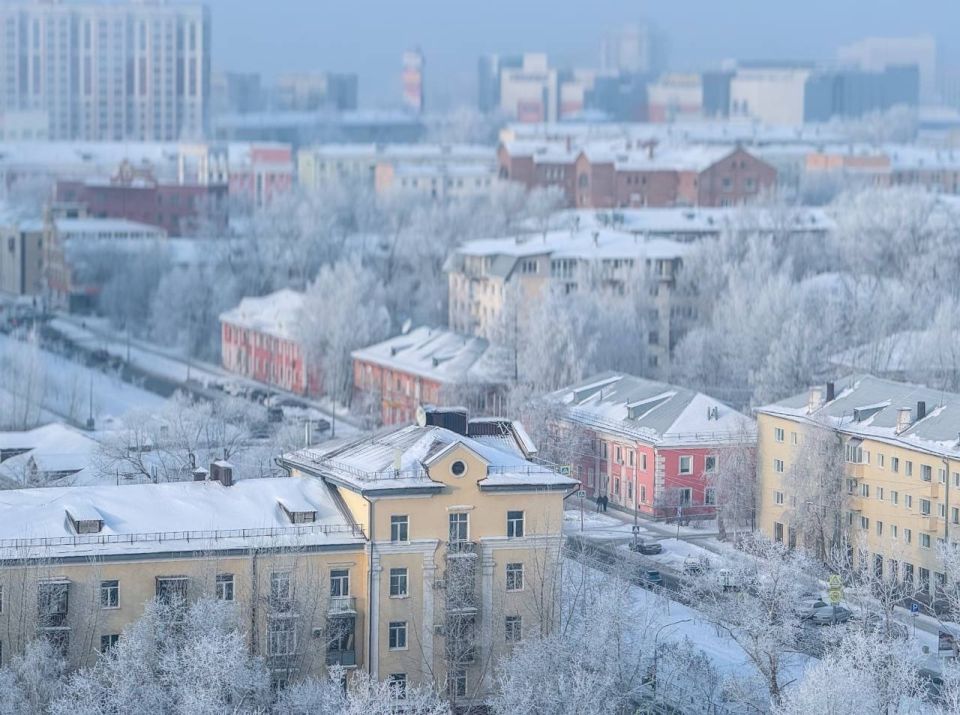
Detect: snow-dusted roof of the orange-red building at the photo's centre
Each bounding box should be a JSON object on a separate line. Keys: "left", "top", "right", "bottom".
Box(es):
{"left": 351, "top": 326, "right": 512, "bottom": 384}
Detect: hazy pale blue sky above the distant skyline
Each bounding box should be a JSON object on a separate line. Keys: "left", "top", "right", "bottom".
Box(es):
{"left": 207, "top": 0, "right": 960, "bottom": 107}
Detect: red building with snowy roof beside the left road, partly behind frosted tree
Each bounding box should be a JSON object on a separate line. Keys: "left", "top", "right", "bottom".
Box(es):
{"left": 220, "top": 289, "right": 321, "bottom": 395}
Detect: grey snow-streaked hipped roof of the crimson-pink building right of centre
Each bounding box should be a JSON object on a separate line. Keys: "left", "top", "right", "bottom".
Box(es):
{"left": 551, "top": 372, "right": 755, "bottom": 446}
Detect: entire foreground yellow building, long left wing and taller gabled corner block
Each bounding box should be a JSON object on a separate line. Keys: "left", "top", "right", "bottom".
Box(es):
{"left": 0, "top": 409, "right": 577, "bottom": 703}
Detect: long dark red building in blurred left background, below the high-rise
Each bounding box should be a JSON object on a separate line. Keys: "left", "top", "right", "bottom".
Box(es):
{"left": 54, "top": 162, "right": 228, "bottom": 236}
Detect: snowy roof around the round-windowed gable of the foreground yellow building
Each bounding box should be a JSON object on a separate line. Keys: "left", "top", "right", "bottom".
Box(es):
{"left": 283, "top": 425, "right": 576, "bottom": 493}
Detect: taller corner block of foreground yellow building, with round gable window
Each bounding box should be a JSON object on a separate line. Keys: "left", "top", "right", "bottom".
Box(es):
{"left": 283, "top": 409, "right": 577, "bottom": 703}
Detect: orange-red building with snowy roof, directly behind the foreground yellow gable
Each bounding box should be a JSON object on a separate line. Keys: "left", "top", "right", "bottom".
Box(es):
{"left": 352, "top": 327, "right": 513, "bottom": 425}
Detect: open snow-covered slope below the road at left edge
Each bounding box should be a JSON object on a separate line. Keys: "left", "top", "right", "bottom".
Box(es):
{"left": 0, "top": 335, "right": 165, "bottom": 428}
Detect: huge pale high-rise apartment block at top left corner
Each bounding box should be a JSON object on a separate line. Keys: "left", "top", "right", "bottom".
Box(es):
{"left": 0, "top": 0, "right": 210, "bottom": 141}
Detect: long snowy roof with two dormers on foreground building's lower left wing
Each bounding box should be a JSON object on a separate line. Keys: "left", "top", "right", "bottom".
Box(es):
{"left": 0, "top": 477, "right": 363, "bottom": 560}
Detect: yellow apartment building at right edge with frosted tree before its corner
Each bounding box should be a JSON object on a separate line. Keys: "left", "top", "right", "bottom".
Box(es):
{"left": 757, "top": 375, "right": 960, "bottom": 596}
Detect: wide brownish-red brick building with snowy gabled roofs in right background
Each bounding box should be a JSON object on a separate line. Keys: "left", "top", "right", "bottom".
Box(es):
{"left": 497, "top": 139, "right": 777, "bottom": 208}
